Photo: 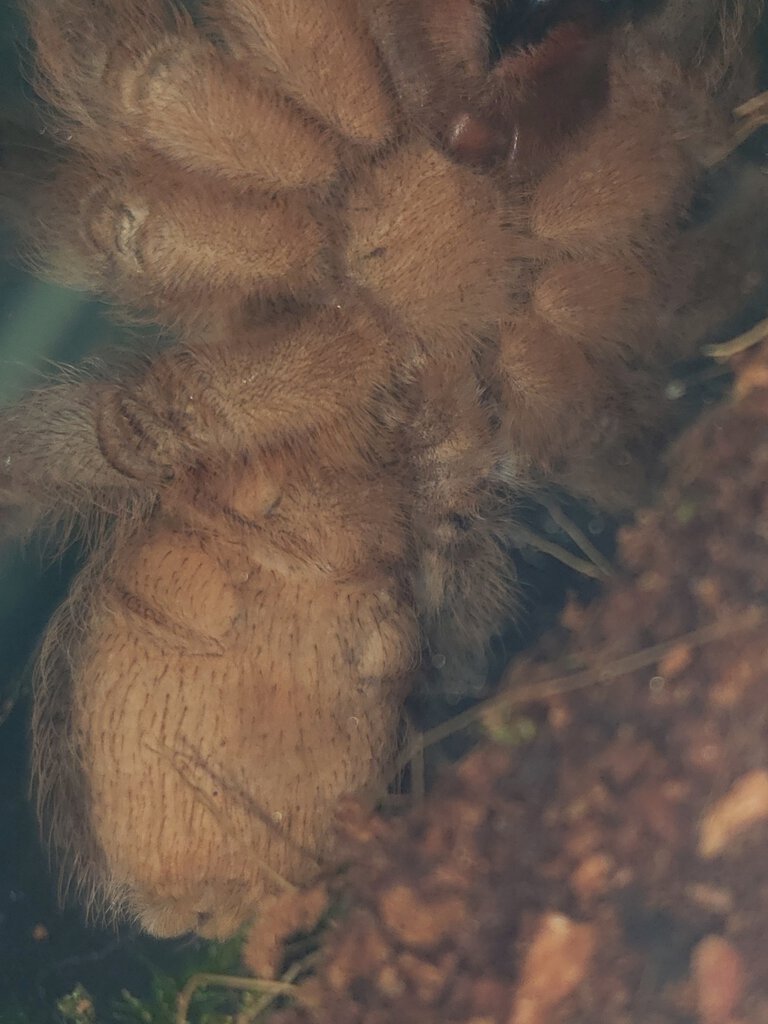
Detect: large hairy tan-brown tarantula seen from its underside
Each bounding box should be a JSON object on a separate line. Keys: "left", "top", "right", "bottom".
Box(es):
{"left": 0, "top": 0, "right": 757, "bottom": 935}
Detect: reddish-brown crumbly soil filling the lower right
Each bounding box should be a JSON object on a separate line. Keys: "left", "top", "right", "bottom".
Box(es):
{"left": 249, "top": 335, "right": 768, "bottom": 1024}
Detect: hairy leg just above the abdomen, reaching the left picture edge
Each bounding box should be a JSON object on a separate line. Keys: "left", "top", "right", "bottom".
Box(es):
{"left": 0, "top": 309, "right": 391, "bottom": 528}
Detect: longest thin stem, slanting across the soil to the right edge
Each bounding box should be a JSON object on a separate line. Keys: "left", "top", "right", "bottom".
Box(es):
{"left": 398, "top": 608, "right": 768, "bottom": 771}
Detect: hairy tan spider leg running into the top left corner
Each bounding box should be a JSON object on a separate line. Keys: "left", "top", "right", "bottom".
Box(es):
{"left": 29, "top": 0, "right": 338, "bottom": 189}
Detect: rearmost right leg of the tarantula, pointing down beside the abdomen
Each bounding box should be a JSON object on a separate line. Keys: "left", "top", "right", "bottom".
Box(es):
{"left": 412, "top": 360, "right": 516, "bottom": 695}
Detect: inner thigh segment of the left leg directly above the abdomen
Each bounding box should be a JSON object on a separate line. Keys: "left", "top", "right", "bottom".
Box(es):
{"left": 119, "top": 307, "right": 403, "bottom": 466}
